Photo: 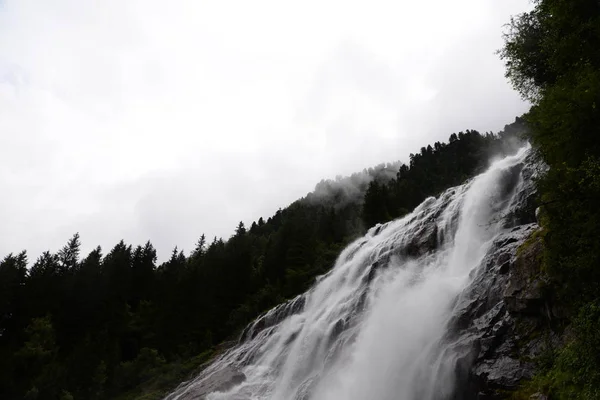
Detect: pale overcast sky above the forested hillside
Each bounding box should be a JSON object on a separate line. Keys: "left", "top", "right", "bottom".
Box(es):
{"left": 0, "top": 0, "right": 530, "bottom": 261}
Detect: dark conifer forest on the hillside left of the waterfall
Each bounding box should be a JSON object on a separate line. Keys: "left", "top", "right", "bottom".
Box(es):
{"left": 0, "top": 123, "right": 524, "bottom": 400}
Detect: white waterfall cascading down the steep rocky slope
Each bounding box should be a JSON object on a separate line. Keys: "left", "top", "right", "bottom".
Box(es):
{"left": 167, "top": 148, "right": 529, "bottom": 400}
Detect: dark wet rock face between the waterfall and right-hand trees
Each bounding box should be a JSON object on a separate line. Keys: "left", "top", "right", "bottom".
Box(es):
{"left": 449, "top": 223, "right": 559, "bottom": 400}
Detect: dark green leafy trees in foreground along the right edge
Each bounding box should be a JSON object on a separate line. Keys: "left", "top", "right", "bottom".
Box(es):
{"left": 500, "top": 0, "right": 600, "bottom": 399}
